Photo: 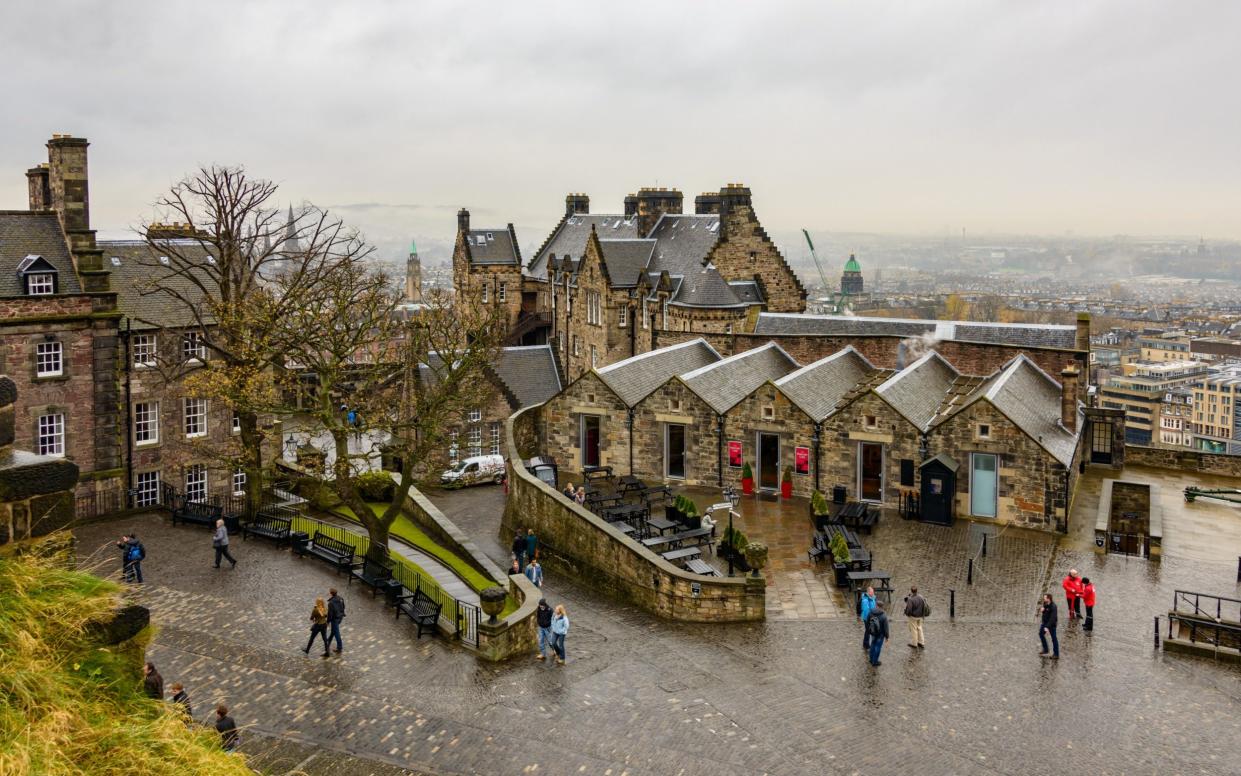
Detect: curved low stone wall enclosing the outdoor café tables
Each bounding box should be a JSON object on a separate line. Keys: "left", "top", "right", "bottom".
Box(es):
{"left": 500, "top": 406, "right": 766, "bottom": 622}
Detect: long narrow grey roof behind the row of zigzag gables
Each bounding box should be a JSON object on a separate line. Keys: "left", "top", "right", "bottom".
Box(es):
{"left": 755, "top": 313, "right": 1077, "bottom": 350}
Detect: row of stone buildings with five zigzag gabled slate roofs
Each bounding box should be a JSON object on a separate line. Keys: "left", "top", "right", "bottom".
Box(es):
{"left": 540, "top": 338, "right": 1087, "bottom": 528}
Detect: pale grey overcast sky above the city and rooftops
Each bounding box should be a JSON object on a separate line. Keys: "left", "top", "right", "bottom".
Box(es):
{"left": 0, "top": 0, "right": 1241, "bottom": 260}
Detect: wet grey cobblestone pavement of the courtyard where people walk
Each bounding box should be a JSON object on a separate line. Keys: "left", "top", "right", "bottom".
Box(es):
{"left": 78, "top": 488, "right": 1241, "bottom": 776}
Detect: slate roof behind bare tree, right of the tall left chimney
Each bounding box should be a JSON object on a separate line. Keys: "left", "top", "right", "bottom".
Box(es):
{"left": 99, "top": 240, "right": 208, "bottom": 330}
